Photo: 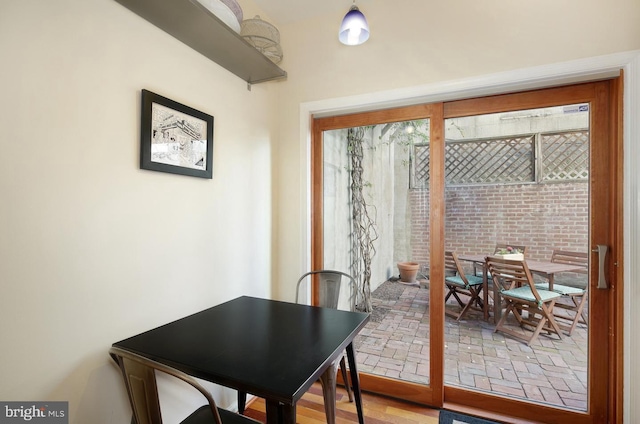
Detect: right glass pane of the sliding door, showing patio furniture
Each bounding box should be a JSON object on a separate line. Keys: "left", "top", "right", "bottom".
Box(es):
{"left": 445, "top": 104, "right": 589, "bottom": 411}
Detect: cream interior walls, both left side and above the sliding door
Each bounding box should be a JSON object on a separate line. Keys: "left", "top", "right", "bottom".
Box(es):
{"left": 0, "top": 0, "right": 640, "bottom": 424}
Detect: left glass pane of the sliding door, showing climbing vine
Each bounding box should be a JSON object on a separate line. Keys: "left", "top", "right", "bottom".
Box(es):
{"left": 323, "top": 119, "right": 429, "bottom": 384}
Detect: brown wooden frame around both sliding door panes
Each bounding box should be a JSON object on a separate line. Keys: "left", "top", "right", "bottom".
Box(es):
{"left": 311, "top": 78, "right": 624, "bottom": 422}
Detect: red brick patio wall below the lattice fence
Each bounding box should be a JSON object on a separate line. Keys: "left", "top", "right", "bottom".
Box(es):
{"left": 409, "top": 183, "right": 588, "bottom": 263}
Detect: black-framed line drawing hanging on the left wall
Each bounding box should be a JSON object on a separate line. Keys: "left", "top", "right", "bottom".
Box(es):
{"left": 140, "top": 90, "right": 213, "bottom": 178}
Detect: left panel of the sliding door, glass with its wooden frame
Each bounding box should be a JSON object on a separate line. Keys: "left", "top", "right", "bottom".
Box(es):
{"left": 313, "top": 105, "right": 442, "bottom": 404}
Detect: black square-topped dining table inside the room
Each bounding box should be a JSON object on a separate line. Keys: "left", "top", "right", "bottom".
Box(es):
{"left": 113, "top": 296, "right": 369, "bottom": 424}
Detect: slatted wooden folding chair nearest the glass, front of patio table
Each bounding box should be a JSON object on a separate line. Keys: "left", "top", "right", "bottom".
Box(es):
{"left": 486, "top": 256, "right": 562, "bottom": 346}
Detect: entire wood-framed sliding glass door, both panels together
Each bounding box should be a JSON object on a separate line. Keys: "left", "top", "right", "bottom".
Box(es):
{"left": 312, "top": 80, "right": 621, "bottom": 422}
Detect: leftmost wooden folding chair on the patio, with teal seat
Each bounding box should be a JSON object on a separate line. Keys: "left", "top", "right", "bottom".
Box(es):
{"left": 444, "top": 251, "right": 486, "bottom": 321}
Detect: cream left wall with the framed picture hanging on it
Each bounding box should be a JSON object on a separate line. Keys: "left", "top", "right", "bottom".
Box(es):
{"left": 0, "top": 0, "right": 276, "bottom": 424}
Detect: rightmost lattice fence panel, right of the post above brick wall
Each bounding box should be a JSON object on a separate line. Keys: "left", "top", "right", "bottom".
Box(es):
{"left": 540, "top": 131, "right": 589, "bottom": 181}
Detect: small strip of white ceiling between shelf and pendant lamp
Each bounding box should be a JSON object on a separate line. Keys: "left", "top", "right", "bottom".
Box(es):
{"left": 249, "top": 0, "right": 360, "bottom": 24}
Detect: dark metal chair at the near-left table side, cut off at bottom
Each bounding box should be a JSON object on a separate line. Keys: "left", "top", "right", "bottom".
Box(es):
{"left": 109, "top": 347, "right": 259, "bottom": 424}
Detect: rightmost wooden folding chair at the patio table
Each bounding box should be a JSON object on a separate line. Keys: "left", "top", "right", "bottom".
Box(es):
{"left": 536, "top": 250, "right": 589, "bottom": 336}
